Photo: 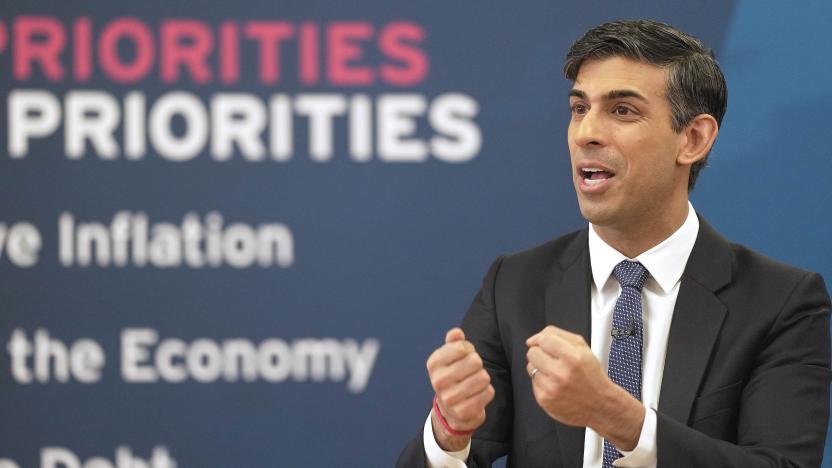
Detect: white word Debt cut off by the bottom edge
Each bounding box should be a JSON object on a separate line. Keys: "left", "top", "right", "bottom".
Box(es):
{"left": 0, "top": 446, "right": 177, "bottom": 468}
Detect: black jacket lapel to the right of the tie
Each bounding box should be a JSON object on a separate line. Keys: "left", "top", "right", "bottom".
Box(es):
{"left": 659, "top": 218, "right": 732, "bottom": 424}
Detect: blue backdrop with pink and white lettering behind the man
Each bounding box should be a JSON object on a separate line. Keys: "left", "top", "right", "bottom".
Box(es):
{"left": 0, "top": 0, "right": 832, "bottom": 468}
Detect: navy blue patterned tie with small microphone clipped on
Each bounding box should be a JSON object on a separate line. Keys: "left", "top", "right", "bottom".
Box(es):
{"left": 603, "top": 260, "right": 650, "bottom": 468}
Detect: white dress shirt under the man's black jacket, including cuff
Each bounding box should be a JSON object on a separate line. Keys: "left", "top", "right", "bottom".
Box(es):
{"left": 423, "top": 202, "right": 699, "bottom": 468}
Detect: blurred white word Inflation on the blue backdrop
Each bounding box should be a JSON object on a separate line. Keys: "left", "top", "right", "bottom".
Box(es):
{"left": 59, "top": 211, "right": 295, "bottom": 268}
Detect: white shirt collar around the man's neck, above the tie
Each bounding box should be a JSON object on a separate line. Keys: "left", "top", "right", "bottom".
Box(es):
{"left": 589, "top": 202, "right": 699, "bottom": 294}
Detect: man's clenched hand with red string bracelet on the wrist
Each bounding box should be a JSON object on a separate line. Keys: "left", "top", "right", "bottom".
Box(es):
{"left": 427, "top": 328, "right": 494, "bottom": 452}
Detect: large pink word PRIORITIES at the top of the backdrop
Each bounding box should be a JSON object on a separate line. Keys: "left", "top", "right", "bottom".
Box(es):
{"left": 0, "top": 16, "right": 430, "bottom": 86}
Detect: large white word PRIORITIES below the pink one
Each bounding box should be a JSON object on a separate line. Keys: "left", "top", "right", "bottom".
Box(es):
{"left": 7, "top": 89, "right": 482, "bottom": 163}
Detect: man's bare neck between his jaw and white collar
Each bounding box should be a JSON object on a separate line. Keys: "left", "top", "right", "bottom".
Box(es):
{"left": 593, "top": 199, "right": 688, "bottom": 258}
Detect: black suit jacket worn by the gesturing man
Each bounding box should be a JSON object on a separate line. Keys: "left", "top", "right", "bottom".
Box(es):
{"left": 397, "top": 219, "right": 832, "bottom": 468}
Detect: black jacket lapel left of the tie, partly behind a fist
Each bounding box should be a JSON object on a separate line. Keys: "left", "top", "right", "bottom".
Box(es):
{"left": 545, "top": 230, "right": 592, "bottom": 466}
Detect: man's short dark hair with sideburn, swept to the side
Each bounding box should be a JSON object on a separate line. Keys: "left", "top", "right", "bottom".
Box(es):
{"left": 563, "top": 20, "right": 728, "bottom": 191}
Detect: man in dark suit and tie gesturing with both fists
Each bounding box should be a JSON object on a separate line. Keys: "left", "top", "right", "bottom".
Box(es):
{"left": 399, "top": 21, "right": 831, "bottom": 468}
